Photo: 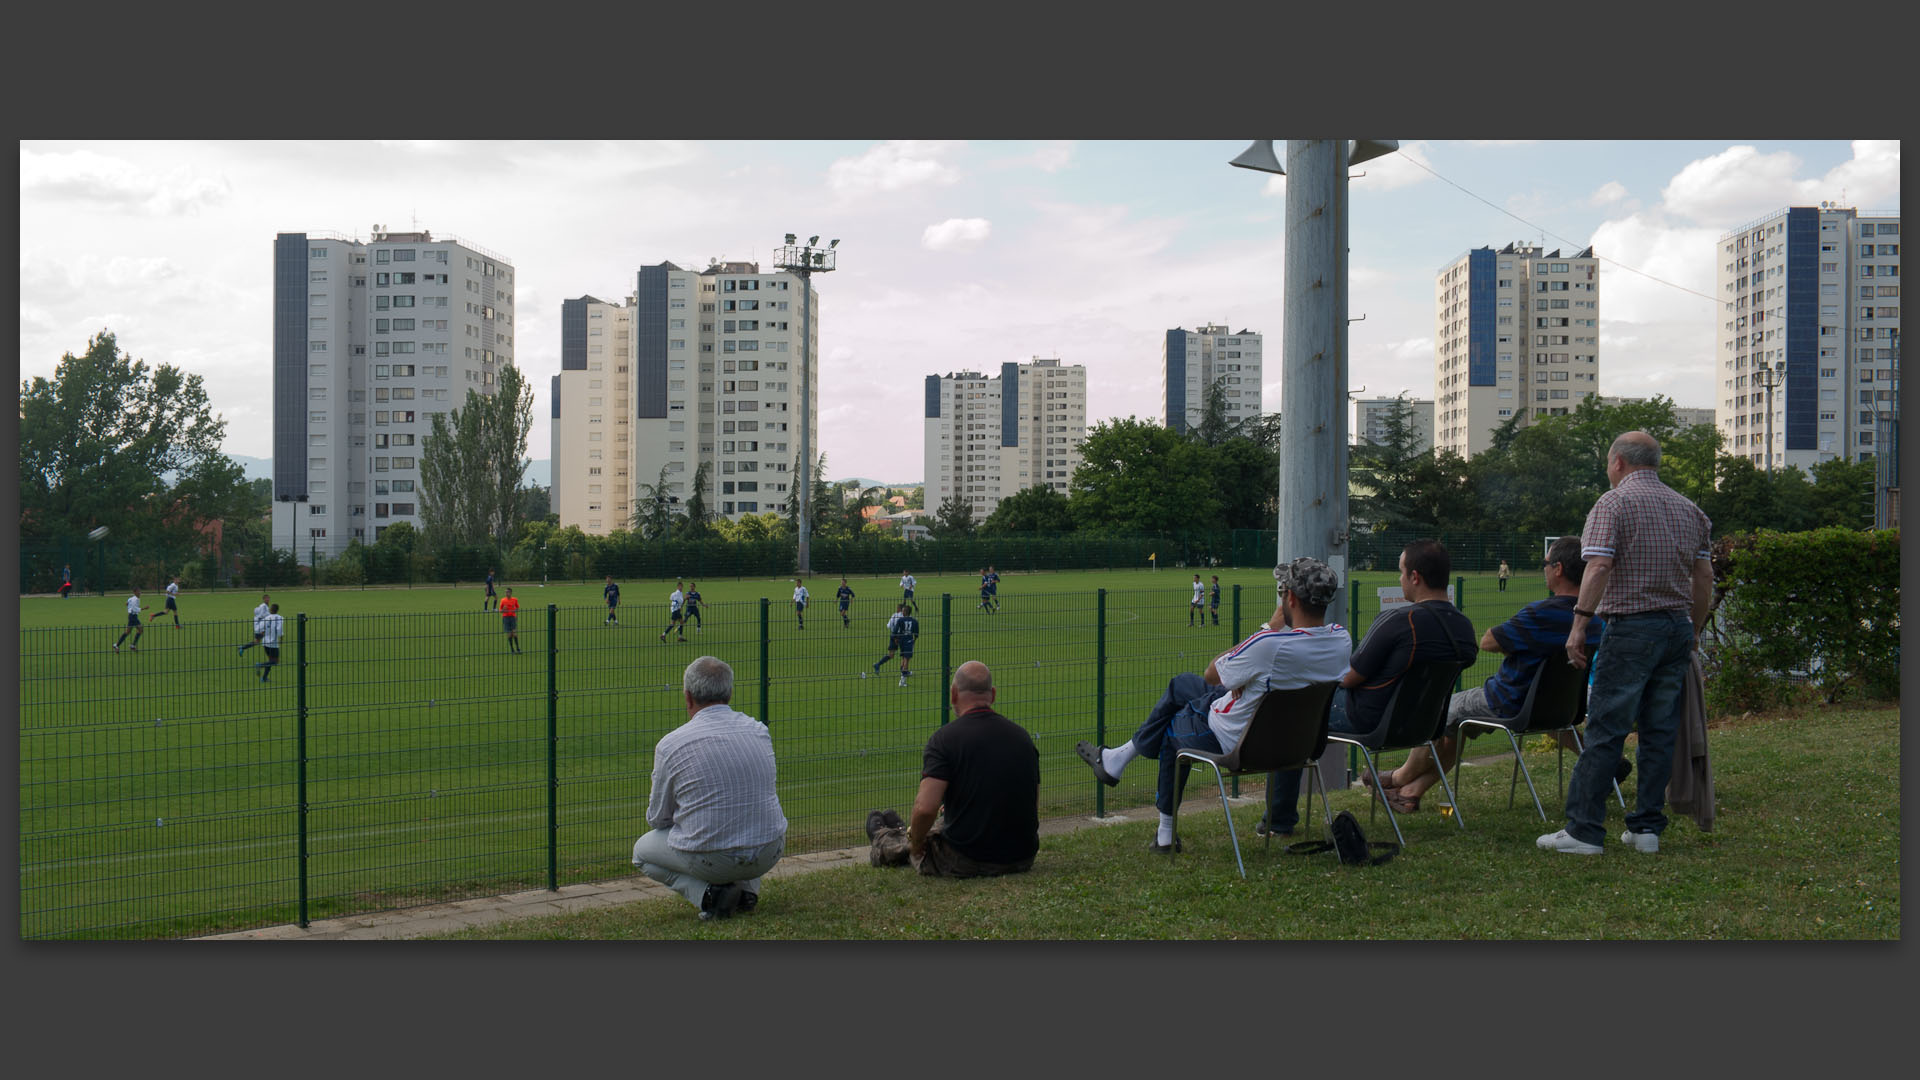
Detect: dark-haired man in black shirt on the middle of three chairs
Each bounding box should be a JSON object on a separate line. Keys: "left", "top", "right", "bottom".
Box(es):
{"left": 1254, "top": 540, "right": 1480, "bottom": 836}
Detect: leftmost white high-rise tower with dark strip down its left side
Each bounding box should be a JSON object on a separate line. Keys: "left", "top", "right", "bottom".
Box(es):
{"left": 273, "top": 225, "right": 513, "bottom": 561}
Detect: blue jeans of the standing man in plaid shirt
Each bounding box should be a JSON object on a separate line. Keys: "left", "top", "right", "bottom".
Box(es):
{"left": 1548, "top": 611, "right": 1693, "bottom": 844}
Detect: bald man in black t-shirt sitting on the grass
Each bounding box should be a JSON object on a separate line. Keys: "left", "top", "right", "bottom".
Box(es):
{"left": 866, "top": 659, "right": 1041, "bottom": 878}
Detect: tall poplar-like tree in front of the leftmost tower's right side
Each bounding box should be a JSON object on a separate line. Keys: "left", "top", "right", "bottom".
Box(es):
{"left": 420, "top": 363, "right": 534, "bottom": 546}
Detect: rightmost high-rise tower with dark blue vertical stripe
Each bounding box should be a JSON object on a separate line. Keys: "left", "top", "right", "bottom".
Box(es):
{"left": 1715, "top": 204, "right": 1901, "bottom": 469}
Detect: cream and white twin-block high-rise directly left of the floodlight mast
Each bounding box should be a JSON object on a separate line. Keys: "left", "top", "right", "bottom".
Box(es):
{"left": 551, "top": 261, "right": 820, "bottom": 534}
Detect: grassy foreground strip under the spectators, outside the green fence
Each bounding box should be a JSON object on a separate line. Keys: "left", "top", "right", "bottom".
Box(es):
{"left": 442, "top": 705, "right": 1901, "bottom": 940}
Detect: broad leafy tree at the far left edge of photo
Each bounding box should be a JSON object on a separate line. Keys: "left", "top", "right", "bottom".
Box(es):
{"left": 19, "top": 331, "right": 245, "bottom": 548}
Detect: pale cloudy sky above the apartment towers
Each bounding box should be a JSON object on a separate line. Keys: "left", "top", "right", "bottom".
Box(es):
{"left": 19, "top": 138, "right": 1899, "bottom": 482}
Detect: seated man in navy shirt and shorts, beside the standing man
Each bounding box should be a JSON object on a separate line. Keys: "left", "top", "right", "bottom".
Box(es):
{"left": 1361, "top": 536, "right": 1626, "bottom": 813}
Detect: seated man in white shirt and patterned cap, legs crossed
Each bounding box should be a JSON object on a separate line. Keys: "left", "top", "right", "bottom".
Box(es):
{"left": 1073, "top": 557, "right": 1350, "bottom": 851}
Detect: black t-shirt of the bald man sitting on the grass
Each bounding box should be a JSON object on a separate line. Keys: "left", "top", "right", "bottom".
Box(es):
{"left": 920, "top": 709, "right": 1041, "bottom": 863}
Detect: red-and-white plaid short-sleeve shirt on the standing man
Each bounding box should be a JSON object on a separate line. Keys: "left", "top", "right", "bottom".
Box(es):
{"left": 1580, "top": 469, "right": 1713, "bottom": 615}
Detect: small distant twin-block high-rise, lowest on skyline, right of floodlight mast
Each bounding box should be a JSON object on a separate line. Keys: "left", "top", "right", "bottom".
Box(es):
{"left": 924, "top": 357, "right": 1087, "bottom": 521}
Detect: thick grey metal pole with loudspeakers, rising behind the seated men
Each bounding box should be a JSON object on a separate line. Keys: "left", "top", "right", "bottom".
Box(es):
{"left": 1231, "top": 138, "right": 1400, "bottom": 623}
